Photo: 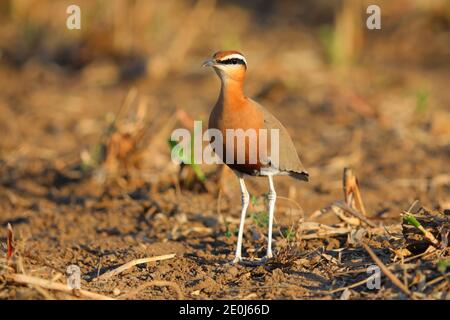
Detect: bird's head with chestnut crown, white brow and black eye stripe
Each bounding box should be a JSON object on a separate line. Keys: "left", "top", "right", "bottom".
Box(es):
{"left": 202, "top": 51, "right": 247, "bottom": 81}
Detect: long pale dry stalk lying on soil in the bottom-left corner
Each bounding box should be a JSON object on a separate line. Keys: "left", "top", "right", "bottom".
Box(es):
{"left": 6, "top": 273, "right": 114, "bottom": 300}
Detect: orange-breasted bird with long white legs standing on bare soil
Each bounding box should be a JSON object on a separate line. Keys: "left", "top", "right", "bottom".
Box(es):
{"left": 202, "top": 50, "right": 309, "bottom": 264}
